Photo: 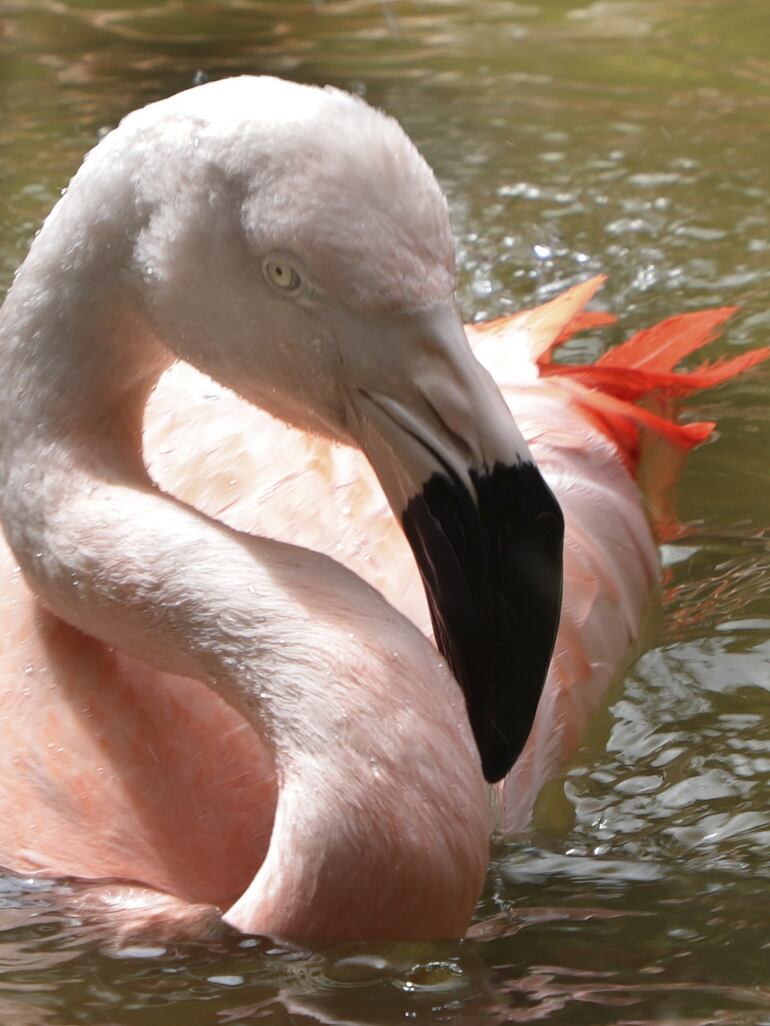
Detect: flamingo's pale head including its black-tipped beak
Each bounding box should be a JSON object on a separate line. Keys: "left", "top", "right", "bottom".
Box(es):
{"left": 128, "top": 79, "right": 563, "bottom": 781}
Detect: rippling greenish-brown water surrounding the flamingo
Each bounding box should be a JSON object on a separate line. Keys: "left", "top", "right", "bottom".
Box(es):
{"left": 0, "top": 0, "right": 770, "bottom": 1026}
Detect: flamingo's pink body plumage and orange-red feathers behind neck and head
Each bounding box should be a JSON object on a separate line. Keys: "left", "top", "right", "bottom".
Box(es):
{"left": 0, "top": 279, "right": 769, "bottom": 932}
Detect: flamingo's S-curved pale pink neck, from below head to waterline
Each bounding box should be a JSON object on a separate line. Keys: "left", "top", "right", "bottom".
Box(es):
{"left": 0, "top": 216, "right": 488, "bottom": 939}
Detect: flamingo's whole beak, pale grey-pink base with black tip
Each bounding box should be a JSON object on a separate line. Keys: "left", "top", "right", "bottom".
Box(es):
{"left": 354, "top": 305, "right": 564, "bottom": 782}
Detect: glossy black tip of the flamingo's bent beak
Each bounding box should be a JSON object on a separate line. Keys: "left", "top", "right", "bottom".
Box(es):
{"left": 403, "top": 463, "right": 564, "bottom": 783}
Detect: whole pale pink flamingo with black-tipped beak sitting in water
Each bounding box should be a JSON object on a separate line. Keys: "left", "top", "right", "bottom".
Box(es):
{"left": 0, "top": 77, "right": 767, "bottom": 941}
